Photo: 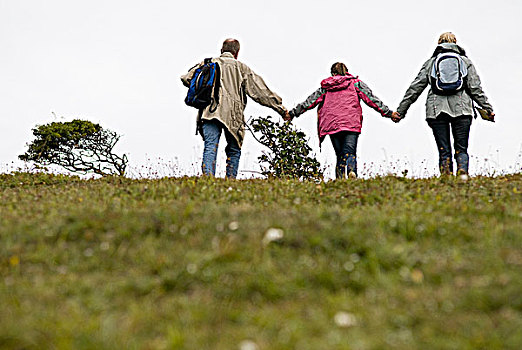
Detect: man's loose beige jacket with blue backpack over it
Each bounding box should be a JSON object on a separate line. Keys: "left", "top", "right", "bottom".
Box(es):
{"left": 181, "top": 52, "right": 286, "bottom": 147}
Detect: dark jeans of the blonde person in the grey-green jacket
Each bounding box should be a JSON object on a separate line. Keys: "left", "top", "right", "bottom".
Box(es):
{"left": 427, "top": 113, "right": 472, "bottom": 175}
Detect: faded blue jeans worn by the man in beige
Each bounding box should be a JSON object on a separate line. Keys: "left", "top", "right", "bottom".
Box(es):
{"left": 201, "top": 119, "right": 241, "bottom": 179}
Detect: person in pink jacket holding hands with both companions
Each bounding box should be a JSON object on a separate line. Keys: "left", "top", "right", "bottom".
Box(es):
{"left": 286, "top": 62, "right": 399, "bottom": 179}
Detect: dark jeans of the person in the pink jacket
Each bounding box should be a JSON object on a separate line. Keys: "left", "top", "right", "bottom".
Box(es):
{"left": 330, "top": 131, "right": 359, "bottom": 179}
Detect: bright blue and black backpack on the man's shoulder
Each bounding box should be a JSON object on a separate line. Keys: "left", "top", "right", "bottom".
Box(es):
{"left": 185, "top": 58, "right": 221, "bottom": 113}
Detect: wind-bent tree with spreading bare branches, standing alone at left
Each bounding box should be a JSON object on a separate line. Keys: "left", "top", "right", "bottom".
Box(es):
{"left": 18, "top": 119, "right": 127, "bottom": 176}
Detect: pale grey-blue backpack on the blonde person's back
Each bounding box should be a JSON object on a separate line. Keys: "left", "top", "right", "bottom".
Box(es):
{"left": 430, "top": 52, "right": 468, "bottom": 96}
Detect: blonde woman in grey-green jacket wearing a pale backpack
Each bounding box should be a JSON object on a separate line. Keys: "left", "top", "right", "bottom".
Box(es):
{"left": 397, "top": 32, "right": 495, "bottom": 178}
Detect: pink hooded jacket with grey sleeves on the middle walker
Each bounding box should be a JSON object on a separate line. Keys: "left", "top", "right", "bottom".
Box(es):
{"left": 290, "top": 74, "right": 392, "bottom": 142}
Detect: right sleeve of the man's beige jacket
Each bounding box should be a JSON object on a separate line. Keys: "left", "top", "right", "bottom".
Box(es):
{"left": 244, "top": 65, "right": 286, "bottom": 115}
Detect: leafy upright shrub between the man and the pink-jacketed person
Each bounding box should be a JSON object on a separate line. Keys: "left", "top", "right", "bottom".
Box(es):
{"left": 250, "top": 116, "right": 323, "bottom": 180}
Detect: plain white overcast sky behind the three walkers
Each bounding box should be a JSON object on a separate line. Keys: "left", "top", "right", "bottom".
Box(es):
{"left": 0, "top": 0, "right": 522, "bottom": 177}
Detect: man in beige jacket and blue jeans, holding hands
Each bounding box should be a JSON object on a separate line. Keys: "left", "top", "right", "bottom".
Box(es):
{"left": 181, "top": 39, "right": 287, "bottom": 178}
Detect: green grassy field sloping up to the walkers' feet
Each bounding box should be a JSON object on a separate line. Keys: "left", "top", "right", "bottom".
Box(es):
{"left": 0, "top": 173, "right": 522, "bottom": 350}
